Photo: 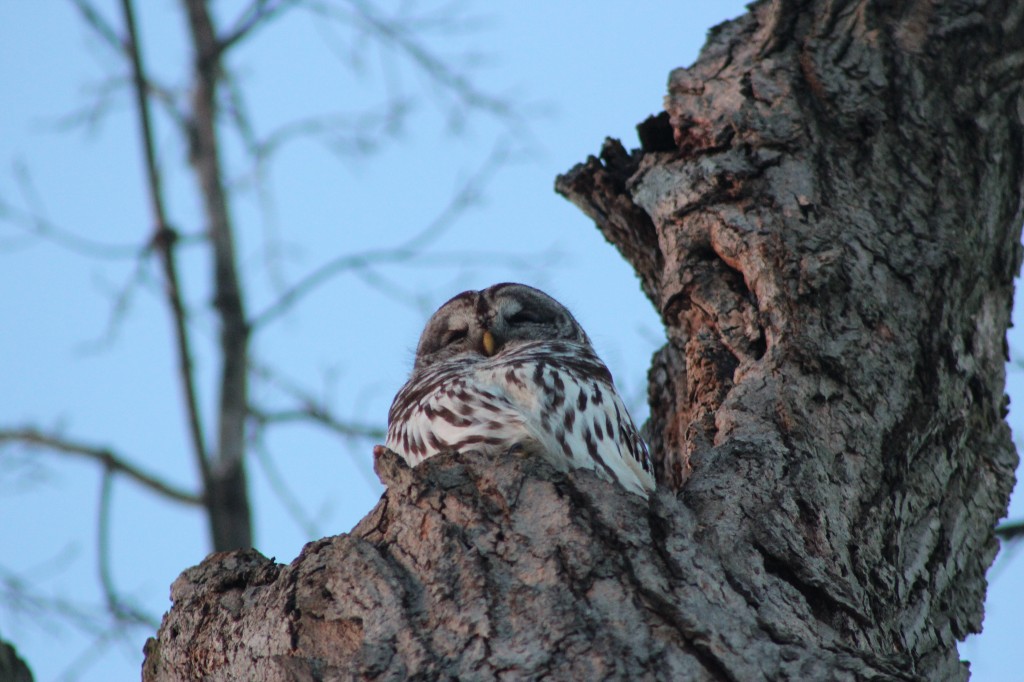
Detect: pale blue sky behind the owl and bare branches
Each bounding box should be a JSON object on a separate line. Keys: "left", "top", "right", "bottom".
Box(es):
{"left": 0, "top": 0, "right": 1024, "bottom": 680}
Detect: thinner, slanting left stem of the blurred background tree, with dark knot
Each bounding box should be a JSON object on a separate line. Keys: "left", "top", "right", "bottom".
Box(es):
{"left": 121, "top": 0, "right": 210, "bottom": 486}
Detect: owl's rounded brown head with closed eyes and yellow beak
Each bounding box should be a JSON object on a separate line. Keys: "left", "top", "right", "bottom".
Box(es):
{"left": 414, "top": 283, "right": 590, "bottom": 371}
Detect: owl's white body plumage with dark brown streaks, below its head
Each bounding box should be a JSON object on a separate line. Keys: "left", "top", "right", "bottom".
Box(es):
{"left": 387, "top": 344, "right": 654, "bottom": 497}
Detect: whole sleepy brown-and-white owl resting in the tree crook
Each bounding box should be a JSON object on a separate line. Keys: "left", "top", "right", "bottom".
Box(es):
{"left": 386, "top": 284, "right": 654, "bottom": 497}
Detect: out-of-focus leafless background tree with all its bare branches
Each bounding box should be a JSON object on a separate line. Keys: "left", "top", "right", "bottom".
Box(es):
{"left": 0, "top": 0, "right": 524, "bottom": 671}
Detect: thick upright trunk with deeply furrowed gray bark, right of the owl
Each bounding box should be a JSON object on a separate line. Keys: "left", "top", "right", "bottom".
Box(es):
{"left": 556, "top": 0, "right": 1024, "bottom": 680}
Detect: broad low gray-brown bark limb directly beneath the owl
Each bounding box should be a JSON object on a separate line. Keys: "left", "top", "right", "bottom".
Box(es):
{"left": 143, "top": 449, "right": 902, "bottom": 681}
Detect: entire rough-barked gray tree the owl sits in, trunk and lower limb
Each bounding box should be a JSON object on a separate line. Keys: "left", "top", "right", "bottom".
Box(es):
{"left": 143, "top": 1, "right": 1024, "bottom": 680}
